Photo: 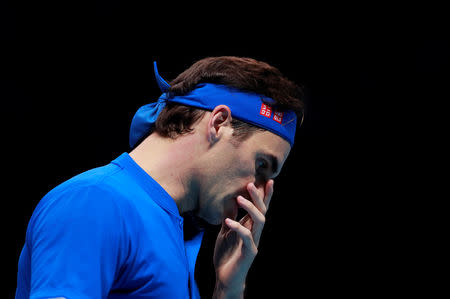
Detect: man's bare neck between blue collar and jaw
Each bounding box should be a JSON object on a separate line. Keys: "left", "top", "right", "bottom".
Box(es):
{"left": 130, "top": 133, "right": 199, "bottom": 214}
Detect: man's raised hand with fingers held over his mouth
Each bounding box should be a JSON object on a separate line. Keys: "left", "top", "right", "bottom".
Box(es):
{"left": 213, "top": 180, "right": 274, "bottom": 298}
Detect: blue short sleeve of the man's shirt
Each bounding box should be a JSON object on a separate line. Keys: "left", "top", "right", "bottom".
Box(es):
{"left": 29, "top": 186, "right": 125, "bottom": 298}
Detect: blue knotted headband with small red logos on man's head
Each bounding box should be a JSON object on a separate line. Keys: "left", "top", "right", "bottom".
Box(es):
{"left": 130, "top": 62, "right": 297, "bottom": 148}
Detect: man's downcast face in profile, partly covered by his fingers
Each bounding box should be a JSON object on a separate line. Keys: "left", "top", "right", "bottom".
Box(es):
{"left": 198, "top": 129, "right": 291, "bottom": 224}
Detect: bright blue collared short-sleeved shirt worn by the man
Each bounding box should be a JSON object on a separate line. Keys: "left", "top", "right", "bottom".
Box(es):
{"left": 16, "top": 153, "right": 203, "bottom": 299}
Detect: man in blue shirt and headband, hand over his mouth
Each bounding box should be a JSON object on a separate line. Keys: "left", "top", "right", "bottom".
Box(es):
{"left": 16, "top": 57, "right": 303, "bottom": 298}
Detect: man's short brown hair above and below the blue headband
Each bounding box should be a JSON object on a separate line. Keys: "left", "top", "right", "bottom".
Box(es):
{"left": 155, "top": 56, "right": 305, "bottom": 141}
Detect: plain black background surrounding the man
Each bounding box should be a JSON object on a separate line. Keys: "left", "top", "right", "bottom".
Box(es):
{"left": 0, "top": 0, "right": 450, "bottom": 298}
